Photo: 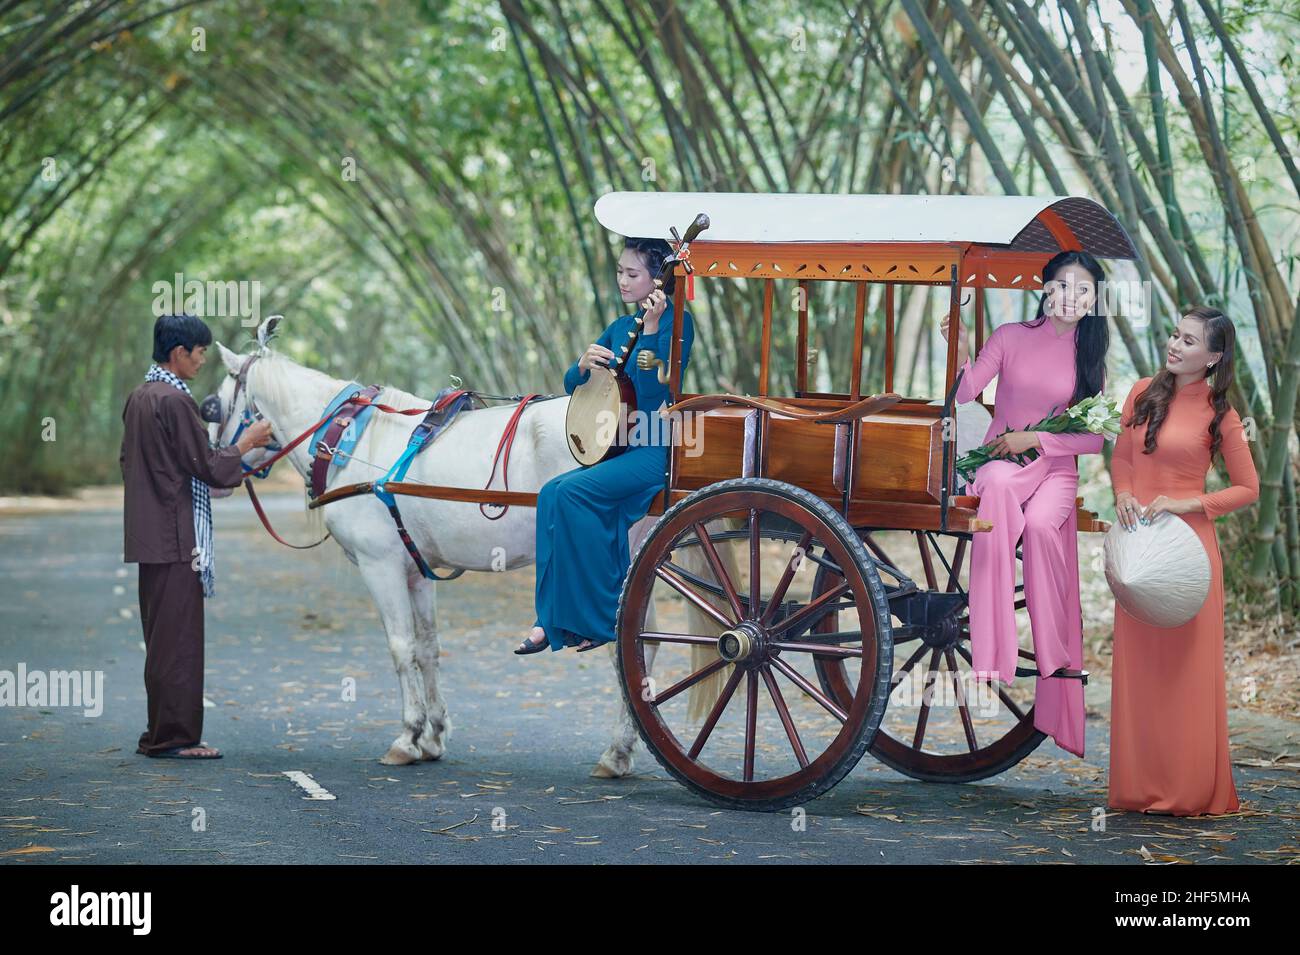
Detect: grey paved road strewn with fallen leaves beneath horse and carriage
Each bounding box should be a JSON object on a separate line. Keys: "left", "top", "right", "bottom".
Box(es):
{"left": 0, "top": 494, "right": 1300, "bottom": 864}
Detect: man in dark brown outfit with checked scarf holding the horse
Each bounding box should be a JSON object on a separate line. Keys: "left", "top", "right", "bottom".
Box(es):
{"left": 121, "top": 314, "right": 270, "bottom": 759}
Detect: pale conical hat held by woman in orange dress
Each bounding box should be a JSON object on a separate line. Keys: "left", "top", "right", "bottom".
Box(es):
{"left": 1105, "top": 512, "right": 1210, "bottom": 628}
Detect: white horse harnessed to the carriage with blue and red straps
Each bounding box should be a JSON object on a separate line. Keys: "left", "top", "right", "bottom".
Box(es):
{"left": 217, "top": 320, "right": 718, "bottom": 777}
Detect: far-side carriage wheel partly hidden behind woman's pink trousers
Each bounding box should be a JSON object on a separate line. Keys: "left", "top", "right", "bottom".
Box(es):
{"left": 814, "top": 530, "right": 1045, "bottom": 782}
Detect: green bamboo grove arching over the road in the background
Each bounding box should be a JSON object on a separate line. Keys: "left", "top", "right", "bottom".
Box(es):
{"left": 0, "top": 0, "right": 1300, "bottom": 612}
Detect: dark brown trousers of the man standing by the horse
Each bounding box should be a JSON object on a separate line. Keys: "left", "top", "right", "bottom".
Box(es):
{"left": 137, "top": 561, "right": 203, "bottom": 755}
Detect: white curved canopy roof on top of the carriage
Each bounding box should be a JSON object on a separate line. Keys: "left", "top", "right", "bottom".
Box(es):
{"left": 595, "top": 192, "right": 1135, "bottom": 259}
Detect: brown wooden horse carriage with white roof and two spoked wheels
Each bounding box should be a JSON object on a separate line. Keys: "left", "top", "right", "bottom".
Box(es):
{"left": 595, "top": 192, "right": 1135, "bottom": 809}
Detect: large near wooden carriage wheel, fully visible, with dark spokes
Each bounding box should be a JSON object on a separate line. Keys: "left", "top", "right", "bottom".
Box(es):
{"left": 618, "top": 478, "right": 893, "bottom": 811}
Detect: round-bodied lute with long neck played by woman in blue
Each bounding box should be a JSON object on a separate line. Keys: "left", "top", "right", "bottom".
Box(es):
{"left": 564, "top": 213, "right": 709, "bottom": 466}
